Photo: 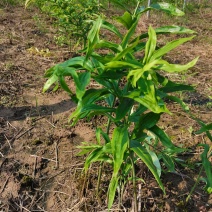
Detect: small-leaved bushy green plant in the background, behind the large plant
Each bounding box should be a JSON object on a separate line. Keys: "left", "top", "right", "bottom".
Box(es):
{"left": 25, "top": 0, "right": 98, "bottom": 46}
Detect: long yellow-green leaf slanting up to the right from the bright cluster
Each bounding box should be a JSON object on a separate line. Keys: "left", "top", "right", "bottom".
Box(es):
{"left": 150, "top": 36, "right": 195, "bottom": 61}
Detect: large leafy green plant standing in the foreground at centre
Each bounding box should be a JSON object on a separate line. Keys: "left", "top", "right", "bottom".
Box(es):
{"left": 43, "top": 1, "right": 198, "bottom": 211}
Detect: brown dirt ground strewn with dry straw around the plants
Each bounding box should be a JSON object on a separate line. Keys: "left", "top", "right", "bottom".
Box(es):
{"left": 0, "top": 4, "right": 212, "bottom": 212}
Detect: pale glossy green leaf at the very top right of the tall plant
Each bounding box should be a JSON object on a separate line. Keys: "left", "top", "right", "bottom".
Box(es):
{"left": 150, "top": 2, "right": 185, "bottom": 16}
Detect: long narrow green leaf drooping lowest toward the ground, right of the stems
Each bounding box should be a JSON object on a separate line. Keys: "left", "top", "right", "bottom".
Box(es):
{"left": 130, "top": 140, "right": 165, "bottom": 193}
